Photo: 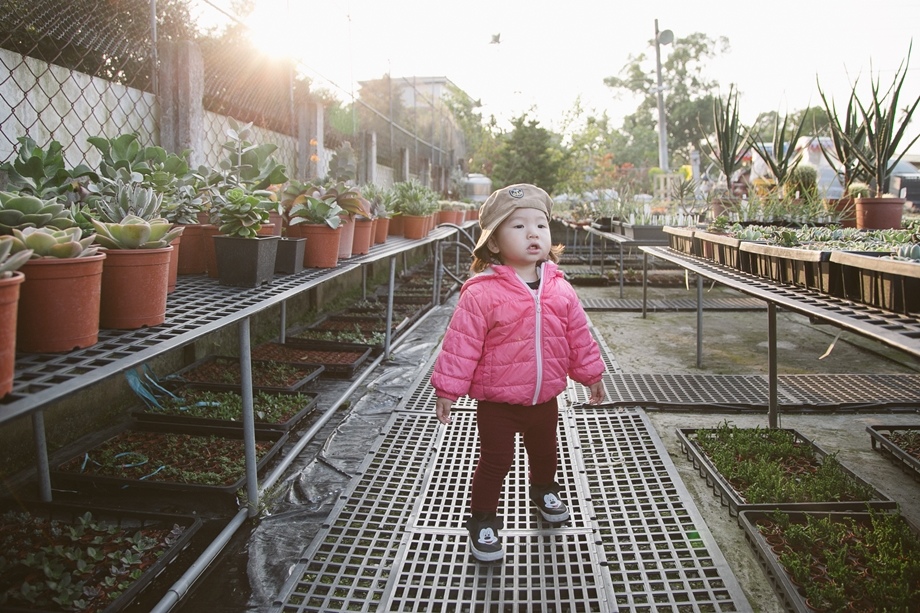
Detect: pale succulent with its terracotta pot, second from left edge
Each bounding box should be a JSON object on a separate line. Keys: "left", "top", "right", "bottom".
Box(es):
{"left": 13, "top": 226, "right": 106, "bottom": 353}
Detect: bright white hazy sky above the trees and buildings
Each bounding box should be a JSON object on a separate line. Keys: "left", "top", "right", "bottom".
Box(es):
{"left": 192, "top": 0, "right": 920, "bottom": 154}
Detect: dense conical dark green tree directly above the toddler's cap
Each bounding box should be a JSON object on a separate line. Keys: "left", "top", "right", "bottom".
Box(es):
{"left": 491, "top": 113, "right": 565, "bottom": 194}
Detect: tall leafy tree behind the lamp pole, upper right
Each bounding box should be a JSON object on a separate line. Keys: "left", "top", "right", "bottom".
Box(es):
{"left": 604, "top": 32, "right": 729, "bottom": 167}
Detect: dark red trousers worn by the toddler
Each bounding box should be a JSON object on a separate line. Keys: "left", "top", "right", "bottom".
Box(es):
{"left": 470, "top": 398, "right": 559, "bottom": 513}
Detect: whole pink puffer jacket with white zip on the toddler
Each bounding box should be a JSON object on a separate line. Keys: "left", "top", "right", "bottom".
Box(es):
{"left": 431, "top": 262, "right": 604, "bottom": 406}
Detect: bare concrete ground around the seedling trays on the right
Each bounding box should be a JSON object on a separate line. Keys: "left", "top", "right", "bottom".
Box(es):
{"left": 576, "top": 285, "right": 920, "bottom": 613}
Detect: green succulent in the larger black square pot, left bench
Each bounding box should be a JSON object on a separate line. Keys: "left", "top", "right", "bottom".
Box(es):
{"left": 214, "top": 187, "right": 280, "bottom": 287}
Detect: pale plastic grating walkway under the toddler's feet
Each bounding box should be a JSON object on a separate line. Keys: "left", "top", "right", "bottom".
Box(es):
{"left": 274, "top": 365, "right": 750, "bottom": 613}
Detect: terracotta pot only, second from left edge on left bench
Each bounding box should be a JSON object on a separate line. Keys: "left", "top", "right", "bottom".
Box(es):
{"left": 16, "top": 253, "right": 106, "bottom": 353}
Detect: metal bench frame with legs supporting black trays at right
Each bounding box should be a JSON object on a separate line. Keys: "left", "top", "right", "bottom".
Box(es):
{"left": 641, "top": 246, "right": 920, "bottom": 428}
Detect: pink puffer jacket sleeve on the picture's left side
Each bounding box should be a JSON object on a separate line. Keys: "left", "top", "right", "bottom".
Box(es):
{"left": 431, "top": 291, "right": 488, "bottom": 400}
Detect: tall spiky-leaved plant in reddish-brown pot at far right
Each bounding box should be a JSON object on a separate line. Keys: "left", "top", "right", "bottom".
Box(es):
{"left": 844, "top": 49, "right": 920, "bottom": 229}
